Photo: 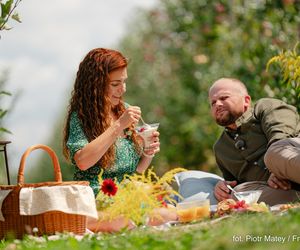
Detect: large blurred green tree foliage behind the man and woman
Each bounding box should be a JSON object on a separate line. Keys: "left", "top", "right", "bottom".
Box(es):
{"left": 121, "top": 0, "right": 300, "bottom": 172}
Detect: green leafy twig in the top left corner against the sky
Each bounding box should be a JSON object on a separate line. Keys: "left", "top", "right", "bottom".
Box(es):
{"left": 0, "top": 0, "right": 22, "bottom": 31}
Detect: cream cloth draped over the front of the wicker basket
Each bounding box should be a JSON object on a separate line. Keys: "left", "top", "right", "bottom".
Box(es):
{"left": 20, "top": 185, "right": 98, "bottom": 218}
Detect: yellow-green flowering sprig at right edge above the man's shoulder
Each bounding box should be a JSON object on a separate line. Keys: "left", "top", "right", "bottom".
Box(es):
{"left": 267, "top": 42, "right": 300, "bottom": 111}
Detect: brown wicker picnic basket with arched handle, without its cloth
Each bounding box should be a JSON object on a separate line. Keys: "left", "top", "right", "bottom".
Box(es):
{"left": 0, "top": 145, "right": 89, "bottom": 239}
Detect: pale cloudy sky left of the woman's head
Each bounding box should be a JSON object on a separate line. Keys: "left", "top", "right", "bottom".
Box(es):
{"left": 0, "top": 0, "right": 157, "bottom": 178}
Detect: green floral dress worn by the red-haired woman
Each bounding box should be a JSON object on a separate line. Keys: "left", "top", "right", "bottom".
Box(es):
{"left": 67, "top": 112, "right": 140, "bottom": 196}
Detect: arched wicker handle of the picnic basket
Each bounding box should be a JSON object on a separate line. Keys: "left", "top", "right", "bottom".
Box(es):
{"left": 18, "top": 144, "right": 62, "bottom": 184}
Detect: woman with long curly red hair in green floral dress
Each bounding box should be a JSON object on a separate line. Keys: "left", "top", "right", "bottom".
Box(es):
{"left": 63, "top": 48, "right": 160, "bottom": 195}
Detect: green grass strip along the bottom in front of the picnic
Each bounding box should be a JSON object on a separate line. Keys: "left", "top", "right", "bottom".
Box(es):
{"left": 0, "top": 210, "right": 300, "bottom": 250}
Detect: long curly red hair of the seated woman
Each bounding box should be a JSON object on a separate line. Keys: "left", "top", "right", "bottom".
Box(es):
{"left": 63, "top": 48, "right": 139, "bottom": 168}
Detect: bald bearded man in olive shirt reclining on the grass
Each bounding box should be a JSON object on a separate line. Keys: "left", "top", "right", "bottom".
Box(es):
{"left": 209, "top": 78, "right": 300, "bottom": 205}
